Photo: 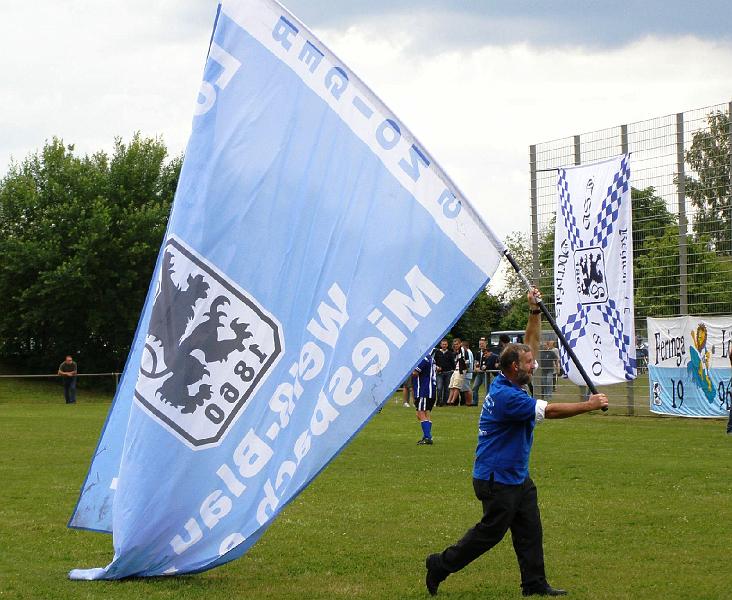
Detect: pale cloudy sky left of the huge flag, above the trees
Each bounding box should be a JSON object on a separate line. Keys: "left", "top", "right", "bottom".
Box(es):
{"left": 0, "top": 0, "right": 216, "bottom": 172}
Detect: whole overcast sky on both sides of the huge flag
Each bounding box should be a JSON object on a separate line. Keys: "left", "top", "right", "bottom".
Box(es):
{"left": 0, "top": 0, "right": 732, "bottom": 252}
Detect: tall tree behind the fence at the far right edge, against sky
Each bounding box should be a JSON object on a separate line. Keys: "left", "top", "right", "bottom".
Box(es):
{"left": 684, "top": 111, "right": 732, "bottom": 254}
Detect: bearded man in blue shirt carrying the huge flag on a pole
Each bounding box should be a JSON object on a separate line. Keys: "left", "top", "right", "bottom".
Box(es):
{"left": 425, "top": 288, "right": 608, "bottom": 596}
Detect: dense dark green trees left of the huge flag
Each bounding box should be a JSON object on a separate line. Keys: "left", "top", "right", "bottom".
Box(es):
{"left": 0, "top": 135, "right": 181, "bottom": 372}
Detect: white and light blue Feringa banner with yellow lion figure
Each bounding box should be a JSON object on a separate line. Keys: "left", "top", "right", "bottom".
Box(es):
{"left": 648, "top": 315, "right": 732, "bottom": 417}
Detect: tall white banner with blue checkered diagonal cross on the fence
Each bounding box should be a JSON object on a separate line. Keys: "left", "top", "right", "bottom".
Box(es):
{"left": 554, "top": 154, "right": 636, "bottom": 385}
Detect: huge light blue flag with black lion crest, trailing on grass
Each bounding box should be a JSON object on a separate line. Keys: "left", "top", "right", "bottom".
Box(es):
{"left": 69, "top": 0, "right": 504, "bottom": 579}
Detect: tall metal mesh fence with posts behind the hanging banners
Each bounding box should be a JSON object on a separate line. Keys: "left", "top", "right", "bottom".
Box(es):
{"left": 529, "top": 102, "right": 732, "bottom": 414}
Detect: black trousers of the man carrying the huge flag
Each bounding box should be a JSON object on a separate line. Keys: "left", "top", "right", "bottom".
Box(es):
{"left": 430, "top": 478, "right": 546, "bottom": 589}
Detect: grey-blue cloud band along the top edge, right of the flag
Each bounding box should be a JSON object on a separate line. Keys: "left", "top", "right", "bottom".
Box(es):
{"left": 284, "top": 0, "right": 732, "bottom": 52}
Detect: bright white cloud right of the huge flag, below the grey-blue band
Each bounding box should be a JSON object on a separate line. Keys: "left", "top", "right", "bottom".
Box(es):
{"left": 321, "top": 22, "right": 732, "bottom": 241}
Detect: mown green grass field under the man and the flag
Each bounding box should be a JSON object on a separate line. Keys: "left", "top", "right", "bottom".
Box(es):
{"left": 0, "top": 380, "right": 732, "bottom": 600}
